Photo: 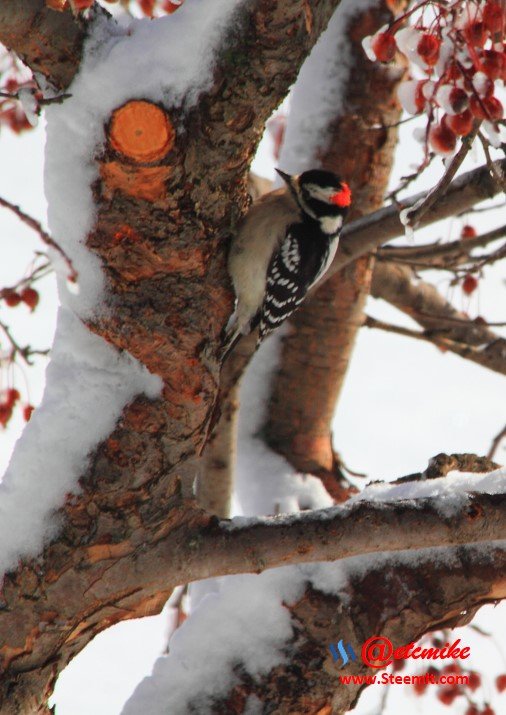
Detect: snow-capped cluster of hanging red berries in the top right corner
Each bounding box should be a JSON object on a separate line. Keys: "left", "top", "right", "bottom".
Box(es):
{"left": 364, "top": 0, "right": 506, "bottom": 154}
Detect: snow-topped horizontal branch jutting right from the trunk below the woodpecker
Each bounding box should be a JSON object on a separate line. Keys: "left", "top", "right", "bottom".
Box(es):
{"left": 185, "top": 470, "right": 506, "bottom": 579}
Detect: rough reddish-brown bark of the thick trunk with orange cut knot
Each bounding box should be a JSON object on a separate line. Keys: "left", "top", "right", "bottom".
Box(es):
{"left": 0, "top": 0, "right": 504, "bottom": 713}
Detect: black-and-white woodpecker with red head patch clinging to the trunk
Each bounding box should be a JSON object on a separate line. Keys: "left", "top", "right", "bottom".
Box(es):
{"left": 222, "top": 169, "right": 351, "bottom": 357}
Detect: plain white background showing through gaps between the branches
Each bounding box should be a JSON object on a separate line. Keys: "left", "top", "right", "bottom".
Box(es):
{"left": 0, "top": 60, "right": 506, "bottom": 715}
